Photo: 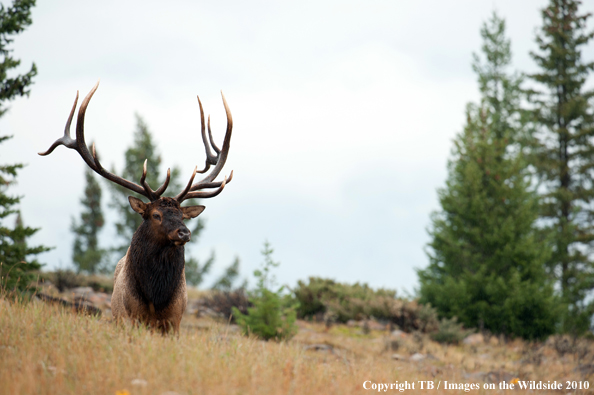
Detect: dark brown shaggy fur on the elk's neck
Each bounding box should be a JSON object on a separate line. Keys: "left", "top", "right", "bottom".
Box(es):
{"left": 126, "top": 222, "right": 185, "bottom": 312}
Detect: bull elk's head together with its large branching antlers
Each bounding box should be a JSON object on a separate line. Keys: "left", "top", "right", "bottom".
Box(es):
{"left": 39, "top": 81, "right": 233, "bottom": 227}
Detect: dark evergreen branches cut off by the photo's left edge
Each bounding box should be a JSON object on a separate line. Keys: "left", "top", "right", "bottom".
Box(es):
{"left": 0, "top": 0, "right": 49, "bottom": 290}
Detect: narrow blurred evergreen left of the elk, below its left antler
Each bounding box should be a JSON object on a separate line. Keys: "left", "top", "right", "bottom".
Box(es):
{"left": 71, "top": 169, "right": 106, "bottom": 274}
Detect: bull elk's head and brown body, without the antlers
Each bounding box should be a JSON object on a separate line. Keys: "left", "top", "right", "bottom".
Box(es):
{"left": 111, "top": 198, "right": 204, "bottom": 334}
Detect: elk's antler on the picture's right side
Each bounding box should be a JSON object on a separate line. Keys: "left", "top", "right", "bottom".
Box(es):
{"left": 175, "top": 92, "right": 233, "bottom": 203}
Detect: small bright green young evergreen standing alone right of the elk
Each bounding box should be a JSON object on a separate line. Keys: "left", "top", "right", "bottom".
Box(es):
{"left": 232, "top": 242, "right": 297, "bottom": 341}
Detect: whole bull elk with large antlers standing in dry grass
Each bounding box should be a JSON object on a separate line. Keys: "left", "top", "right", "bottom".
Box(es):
{"left": 39, "top": 82, "right": 233, "bottom": 334}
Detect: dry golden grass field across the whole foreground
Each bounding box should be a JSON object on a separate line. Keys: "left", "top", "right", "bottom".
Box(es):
{"left": 0, "top": 299, "right": 594, "bottom": 395}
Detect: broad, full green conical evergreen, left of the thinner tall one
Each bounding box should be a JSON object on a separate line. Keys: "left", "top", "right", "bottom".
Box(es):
{"left": 418, "top": 14, "right": 556, "bottom": 339}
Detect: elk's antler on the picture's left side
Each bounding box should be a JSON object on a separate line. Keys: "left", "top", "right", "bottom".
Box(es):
{"left": 39, "top": 81, "right": 171, "bottom": 201}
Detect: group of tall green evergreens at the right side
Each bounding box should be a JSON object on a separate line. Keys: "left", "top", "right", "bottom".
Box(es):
{"left": 418, "top": 0, "right": 594, "bottom": 339}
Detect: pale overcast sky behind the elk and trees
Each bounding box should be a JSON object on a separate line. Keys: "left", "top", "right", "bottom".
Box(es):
{"left": 0, "top": 0, "right": 594, "bottom": 293}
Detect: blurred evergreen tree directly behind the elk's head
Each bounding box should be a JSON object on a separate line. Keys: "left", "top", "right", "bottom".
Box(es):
{"left": 109, "top": 114, "right": 212, "bottom": 286}
